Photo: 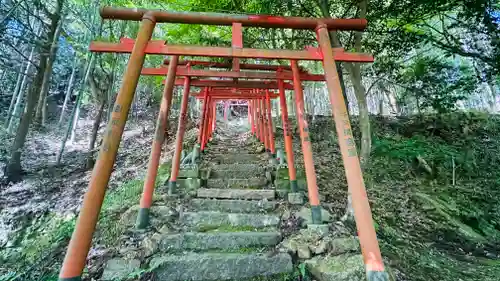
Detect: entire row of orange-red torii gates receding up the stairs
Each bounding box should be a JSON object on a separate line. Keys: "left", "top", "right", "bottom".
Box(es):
{"left": 59, "top": 7, "right": 388, "bottom": 281}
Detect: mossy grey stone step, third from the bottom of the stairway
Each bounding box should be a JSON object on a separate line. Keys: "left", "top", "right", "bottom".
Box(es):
{"left": 181, "top": 211, "right": 280, "bottom": 230}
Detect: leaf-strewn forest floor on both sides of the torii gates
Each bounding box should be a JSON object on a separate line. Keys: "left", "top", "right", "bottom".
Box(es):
{"left": 0, "top": 110, "right": 500, "bottom": 281}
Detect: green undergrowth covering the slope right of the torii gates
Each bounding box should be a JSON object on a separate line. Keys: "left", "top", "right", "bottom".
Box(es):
{"left": 304, "top": 112, "right": 500, "bottom": 281}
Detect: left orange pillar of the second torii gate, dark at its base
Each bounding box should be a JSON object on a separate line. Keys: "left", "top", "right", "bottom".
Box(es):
{"left": 137, "top": 56, "right": 179, "bottom": 229}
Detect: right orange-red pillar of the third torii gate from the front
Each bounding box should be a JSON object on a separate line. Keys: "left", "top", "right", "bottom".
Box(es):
{"left": 278, "top": 79, "right": 298, "bottom": 193}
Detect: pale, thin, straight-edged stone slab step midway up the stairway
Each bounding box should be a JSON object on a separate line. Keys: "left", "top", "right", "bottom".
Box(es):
{"left": 197, "top": 188, "right": 275, "bottom": 200}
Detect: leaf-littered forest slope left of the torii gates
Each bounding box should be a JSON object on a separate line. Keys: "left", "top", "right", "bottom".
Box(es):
{"left": 0, "top": 111, "right": 195, "bottom": 281}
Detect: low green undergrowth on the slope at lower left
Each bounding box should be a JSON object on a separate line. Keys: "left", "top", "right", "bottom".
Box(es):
{"left": 0, "top": 163, "right": 170, "bottom": 281}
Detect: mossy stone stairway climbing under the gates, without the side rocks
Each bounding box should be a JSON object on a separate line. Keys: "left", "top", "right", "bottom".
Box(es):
{"left": 149, "top": 132, "right": 293, "bottom": 281}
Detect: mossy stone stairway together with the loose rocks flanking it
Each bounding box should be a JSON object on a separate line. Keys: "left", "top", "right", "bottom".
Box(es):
{"left": 101, "top": 125, "right": 366, "bottom": 281}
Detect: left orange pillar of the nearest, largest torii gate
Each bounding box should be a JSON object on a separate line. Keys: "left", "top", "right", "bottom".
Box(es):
{"left": 59, "top": 13, "right": 156, "bottom": 281}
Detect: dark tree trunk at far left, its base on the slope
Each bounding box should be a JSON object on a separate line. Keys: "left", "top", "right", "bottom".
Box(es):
{"left": 5, "top": 55, "right": 47, "bottom": 182}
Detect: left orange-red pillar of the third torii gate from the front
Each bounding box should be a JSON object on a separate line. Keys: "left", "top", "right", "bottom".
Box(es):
{"left": 168, "top": 76, "right": 191, "bottom": 195}
